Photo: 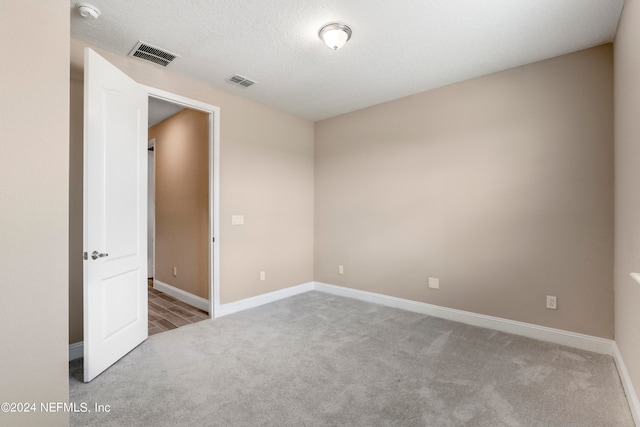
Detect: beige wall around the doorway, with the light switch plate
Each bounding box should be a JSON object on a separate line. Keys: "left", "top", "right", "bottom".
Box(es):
{"left": 69, "top": 40, "right": 313, "bottom": 344}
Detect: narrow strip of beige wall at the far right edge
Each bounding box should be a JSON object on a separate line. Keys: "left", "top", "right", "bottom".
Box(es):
{"left": 615, "top": 0, "right": 640, "bottom": 408}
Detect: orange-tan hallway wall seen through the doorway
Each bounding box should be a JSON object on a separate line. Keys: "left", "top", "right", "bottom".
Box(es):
{"left": 149, "top": 109, "right": 209, "bottom": 299}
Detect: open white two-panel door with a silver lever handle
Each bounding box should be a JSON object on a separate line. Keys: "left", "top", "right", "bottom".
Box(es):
{"left": 83, "top": 48, "right": 148, "bottom": 382}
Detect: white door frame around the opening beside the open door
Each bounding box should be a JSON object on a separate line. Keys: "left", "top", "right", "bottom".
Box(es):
{"left": 142, "top": 85, "right": 220, "bottom": 318}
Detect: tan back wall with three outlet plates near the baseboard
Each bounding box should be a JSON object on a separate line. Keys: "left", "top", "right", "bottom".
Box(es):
{"left": 315, "top": 45, "right": 613, "bottom": 338}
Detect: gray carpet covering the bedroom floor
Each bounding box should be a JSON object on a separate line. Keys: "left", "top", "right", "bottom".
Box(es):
{"left": 69, "top": 292, "right": 633, "bottom": 427}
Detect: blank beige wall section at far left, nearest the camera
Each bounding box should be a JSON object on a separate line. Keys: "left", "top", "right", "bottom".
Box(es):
{"left": 0, "top": 0, "right": 69, "bottom": 426}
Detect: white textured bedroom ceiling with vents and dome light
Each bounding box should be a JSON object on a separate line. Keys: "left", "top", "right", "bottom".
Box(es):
{"left": 70, "top": 0, "right": 624, "bottom": 120}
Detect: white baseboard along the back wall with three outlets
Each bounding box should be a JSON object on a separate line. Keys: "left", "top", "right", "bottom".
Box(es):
{"left": 314, "top": 282, "right": 615, "bottom": 355}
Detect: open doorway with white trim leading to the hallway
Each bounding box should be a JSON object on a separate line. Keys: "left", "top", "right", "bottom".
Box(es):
{"left": 147, "top": 88, "right": 219, "bottom": 335}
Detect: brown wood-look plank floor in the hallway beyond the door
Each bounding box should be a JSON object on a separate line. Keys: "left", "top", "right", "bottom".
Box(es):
{"left": 149, "top": 280, "right": 209, "bottom": 336}
